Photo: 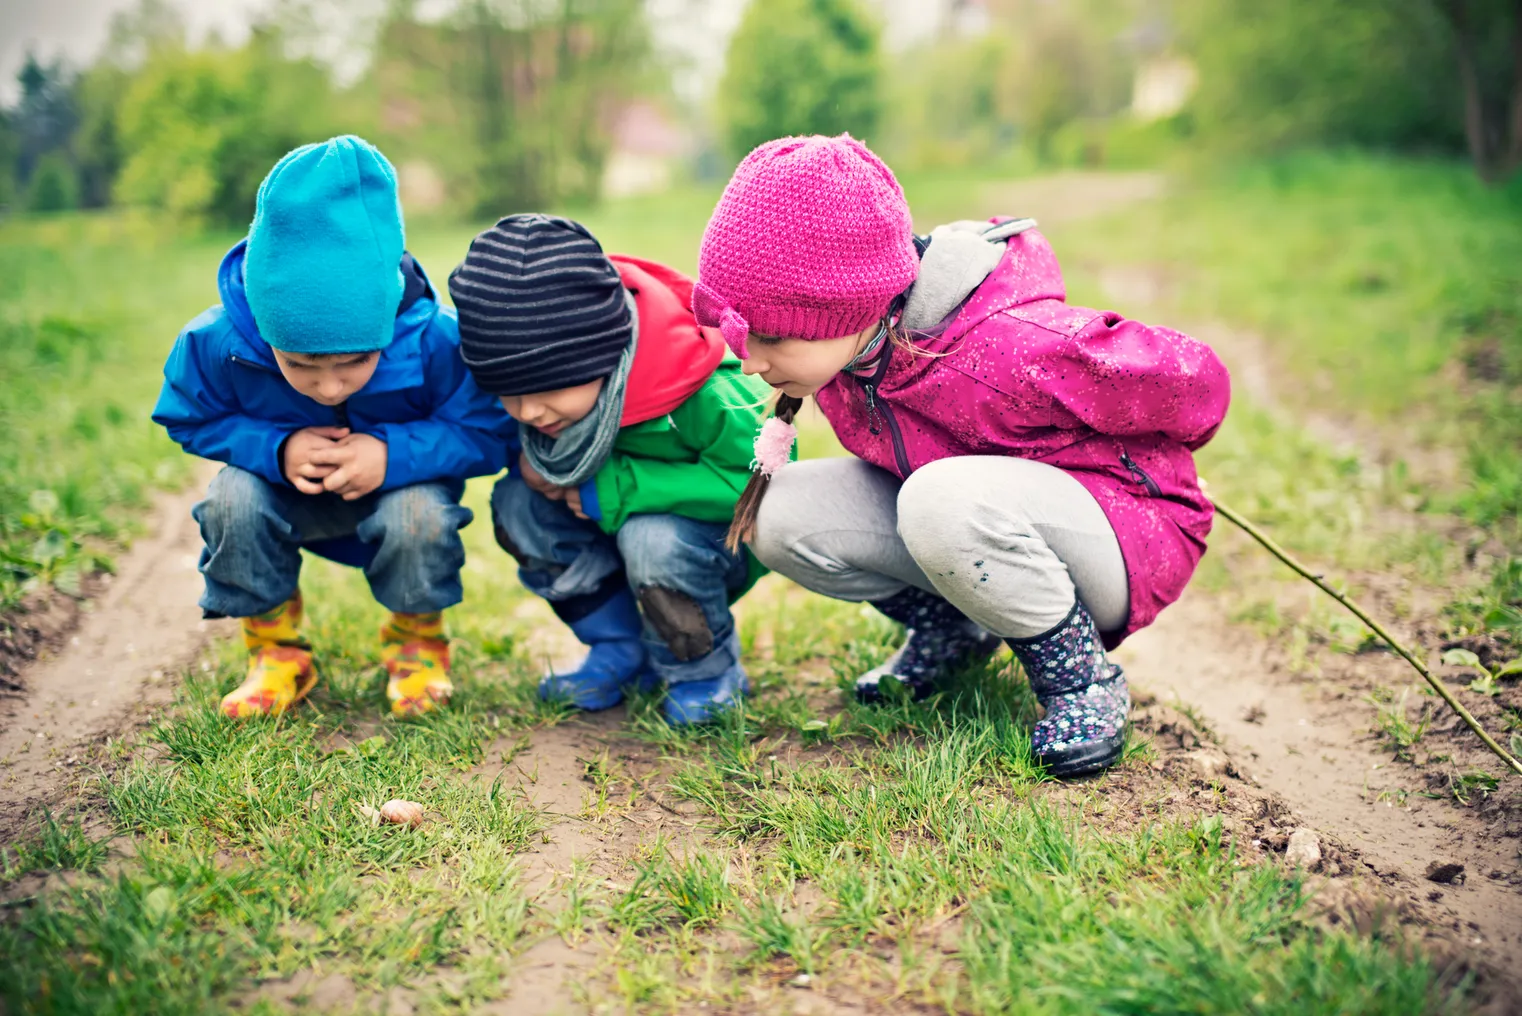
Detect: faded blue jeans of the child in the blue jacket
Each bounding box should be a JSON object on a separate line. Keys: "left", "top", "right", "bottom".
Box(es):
{"left": 190, "top": 465, "right": 475, "bottom": 618}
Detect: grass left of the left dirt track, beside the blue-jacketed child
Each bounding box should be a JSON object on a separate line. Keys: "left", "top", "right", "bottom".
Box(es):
{"left": 0, "top": 216, "right": 224, "bottom": 611}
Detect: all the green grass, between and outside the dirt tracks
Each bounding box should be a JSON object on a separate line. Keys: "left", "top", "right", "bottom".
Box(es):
{"left": 0, "top": 156, "right": 1519, "bottom": 1013}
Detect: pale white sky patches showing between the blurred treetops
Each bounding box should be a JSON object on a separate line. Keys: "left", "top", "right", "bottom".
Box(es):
{"left": 0, "top": 0, "right": 942, "bottom": 105}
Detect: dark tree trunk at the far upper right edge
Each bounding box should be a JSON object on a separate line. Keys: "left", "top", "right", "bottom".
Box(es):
{"left": 1434, "top": 0, "right": 1522, "bottom": 183}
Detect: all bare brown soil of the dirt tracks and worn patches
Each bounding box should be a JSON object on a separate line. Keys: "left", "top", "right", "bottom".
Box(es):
{"left": 0, "top": 173, "right": 1522, "bottom": 1013}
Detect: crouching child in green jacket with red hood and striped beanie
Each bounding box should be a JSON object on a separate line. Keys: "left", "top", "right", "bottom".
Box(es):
{"left": 449, "top": 214, "right": 769, "bottom": 724}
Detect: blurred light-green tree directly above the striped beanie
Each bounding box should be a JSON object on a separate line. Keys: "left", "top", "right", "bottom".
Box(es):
{"left": 372, "top": 0, "right": 654, "bottom": 216}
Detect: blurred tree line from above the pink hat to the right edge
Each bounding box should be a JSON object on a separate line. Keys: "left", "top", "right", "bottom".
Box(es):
{"left": 718, "top": 0, "right": 1522, "bottom": 181}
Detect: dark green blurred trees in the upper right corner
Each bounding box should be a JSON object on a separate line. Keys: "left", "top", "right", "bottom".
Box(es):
{"left": 1175, "top": 0, "right": 1522, "bottom": 181}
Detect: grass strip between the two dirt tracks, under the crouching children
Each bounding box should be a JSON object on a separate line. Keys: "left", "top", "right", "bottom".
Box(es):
{"left": 0, "top": 484, "right": 1464, "bottom": 1013}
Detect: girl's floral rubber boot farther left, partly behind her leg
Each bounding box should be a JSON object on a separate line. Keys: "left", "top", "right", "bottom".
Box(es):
{"left": 855, "top": 586, "right": 1000, "bottom": 706}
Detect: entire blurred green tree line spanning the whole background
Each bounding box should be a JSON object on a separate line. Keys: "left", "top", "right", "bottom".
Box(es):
{"left": 0, "top": 0, "right": 1522, "bottom": 224}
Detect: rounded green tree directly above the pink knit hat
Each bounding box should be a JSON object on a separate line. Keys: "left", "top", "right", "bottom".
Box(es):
{"left": 718, "top": 0, "right": 883, "bottom": 157}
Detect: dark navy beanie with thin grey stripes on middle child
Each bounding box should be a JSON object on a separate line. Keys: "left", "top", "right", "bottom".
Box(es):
{"left": 449, "top": 213, "right": 635, "bottom": 395}
